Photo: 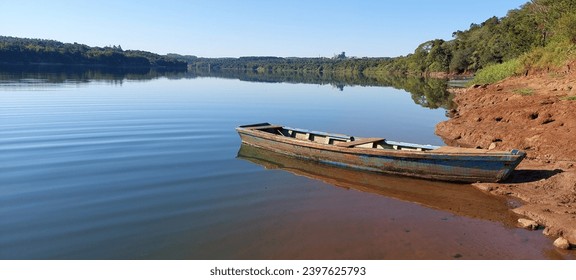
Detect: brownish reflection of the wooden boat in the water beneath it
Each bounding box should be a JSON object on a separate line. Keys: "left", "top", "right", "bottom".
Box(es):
{"left": 238, "top": 143, "right": 517, "bottom": 227}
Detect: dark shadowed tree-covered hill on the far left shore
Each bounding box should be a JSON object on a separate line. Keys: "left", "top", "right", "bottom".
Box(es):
{"left": 0, "top": 36, "right": 187, "bottom": 69}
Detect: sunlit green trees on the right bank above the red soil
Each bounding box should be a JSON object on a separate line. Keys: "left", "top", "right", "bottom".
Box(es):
{"left": 373, "top": 0, "right": 576, "bottom": 74}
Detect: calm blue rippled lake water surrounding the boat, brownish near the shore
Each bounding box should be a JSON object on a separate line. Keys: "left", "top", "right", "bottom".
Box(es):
{"left": 0, "top": 73, "right": 572, "bottom": 259}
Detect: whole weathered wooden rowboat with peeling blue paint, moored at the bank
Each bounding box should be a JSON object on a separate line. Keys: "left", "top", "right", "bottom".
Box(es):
{"left": 236, "top": 123, "right": 526, "bottom": 182}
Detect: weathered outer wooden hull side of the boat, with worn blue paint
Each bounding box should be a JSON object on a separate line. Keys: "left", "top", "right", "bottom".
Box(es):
{"left": 237, "top": 124, "right": 525, "bottom": 182}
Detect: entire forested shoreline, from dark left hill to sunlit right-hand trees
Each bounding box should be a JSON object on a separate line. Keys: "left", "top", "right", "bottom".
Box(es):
{"left": 0, "top": 0, "right": 576, "bottom": 80}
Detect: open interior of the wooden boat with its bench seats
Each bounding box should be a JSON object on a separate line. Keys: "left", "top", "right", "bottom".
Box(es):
{"left": 241, "top": 123, "right": 439, "bottom": 151}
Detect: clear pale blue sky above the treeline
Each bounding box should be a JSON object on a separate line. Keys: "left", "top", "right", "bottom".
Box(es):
{"left": 0, "top": 0, "right": 528, "bottom": 57}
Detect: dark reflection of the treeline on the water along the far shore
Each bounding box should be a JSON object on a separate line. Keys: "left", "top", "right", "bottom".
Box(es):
{"left": 0, "top": 66, "right": 454, "bottom": 110}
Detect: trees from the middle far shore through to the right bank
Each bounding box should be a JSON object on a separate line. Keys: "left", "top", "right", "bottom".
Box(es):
{"left": 171, "top": 0, "right": 576, "bottom": 76}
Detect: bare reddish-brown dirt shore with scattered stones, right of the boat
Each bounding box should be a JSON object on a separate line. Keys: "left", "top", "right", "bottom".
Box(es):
{"left": 436, "top": 69, "right": 576, "bottom": 249}
